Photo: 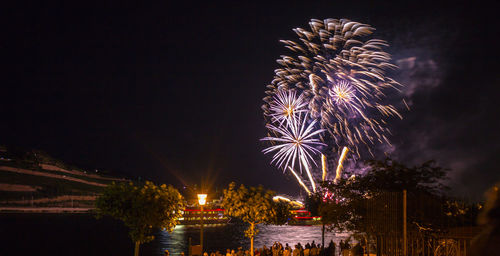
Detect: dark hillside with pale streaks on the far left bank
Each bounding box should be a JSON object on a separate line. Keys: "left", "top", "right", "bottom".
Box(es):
{"left": 0, "top": 146, "right": 126, "bottom": 212}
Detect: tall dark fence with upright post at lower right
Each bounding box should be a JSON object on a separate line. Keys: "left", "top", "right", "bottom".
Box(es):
{"left": 366, "top": 192, "right": 479, "bottom": 256}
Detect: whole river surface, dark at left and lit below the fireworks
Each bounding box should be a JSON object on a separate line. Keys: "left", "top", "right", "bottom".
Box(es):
{"left": 0, "top": 213, "right": 348, "bottom": 256}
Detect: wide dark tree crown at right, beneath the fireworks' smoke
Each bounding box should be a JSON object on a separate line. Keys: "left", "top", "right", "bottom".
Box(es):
{"left": 314, "top": 159, "right": 477, "bottom": 235}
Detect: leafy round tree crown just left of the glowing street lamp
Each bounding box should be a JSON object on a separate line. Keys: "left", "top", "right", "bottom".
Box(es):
{"left": 96, "top": 181, "right": 184, "bottom": 254}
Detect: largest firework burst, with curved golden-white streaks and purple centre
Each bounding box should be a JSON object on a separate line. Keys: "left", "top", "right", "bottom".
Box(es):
{"left": 262, "top": 19, "right": 401, "bottom": 157}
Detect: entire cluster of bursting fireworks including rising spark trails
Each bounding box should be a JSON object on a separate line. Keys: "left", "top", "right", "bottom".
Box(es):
{"left": 262, "top": 19, "right": 406, "bottom": 193}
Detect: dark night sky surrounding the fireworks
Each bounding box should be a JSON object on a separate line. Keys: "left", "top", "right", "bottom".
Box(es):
{"left": 0, "top": 1, "right": 500, "bottom": 198}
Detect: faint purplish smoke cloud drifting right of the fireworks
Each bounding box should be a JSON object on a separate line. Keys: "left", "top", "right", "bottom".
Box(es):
{"left": 372, "top": 48, "right": 500, "bottom": 200}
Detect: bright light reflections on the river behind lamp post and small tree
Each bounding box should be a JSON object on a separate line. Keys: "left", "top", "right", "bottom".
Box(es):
{"left": 152, "top": 224, "right": 349, "bottom": 255}
